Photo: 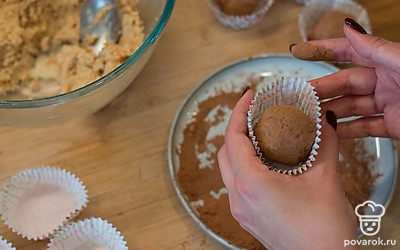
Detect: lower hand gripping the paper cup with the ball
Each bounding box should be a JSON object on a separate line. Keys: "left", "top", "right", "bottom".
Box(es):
{"left": 218, "top": 90, "right": 357, "bottom": 250}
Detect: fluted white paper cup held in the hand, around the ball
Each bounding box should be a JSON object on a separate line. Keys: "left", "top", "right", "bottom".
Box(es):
{"left": 247, "top": 77, "right": 321, "bottom": 175}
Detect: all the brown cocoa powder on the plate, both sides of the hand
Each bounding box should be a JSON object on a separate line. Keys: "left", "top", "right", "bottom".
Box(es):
{"left": 177, "top": 86, "right": 377, "bottom": 249}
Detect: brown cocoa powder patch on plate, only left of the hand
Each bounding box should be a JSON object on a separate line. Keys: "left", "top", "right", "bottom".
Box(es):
{"left": 178, "top": 90, "right": 263, "bottom": 249}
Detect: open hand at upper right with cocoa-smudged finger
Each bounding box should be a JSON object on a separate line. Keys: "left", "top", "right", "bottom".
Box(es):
{"left": 291, "top": 19, "right": 400, "bottom": 139}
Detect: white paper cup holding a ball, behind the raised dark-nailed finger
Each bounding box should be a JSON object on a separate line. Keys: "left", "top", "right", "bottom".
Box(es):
{"left": 298, "top": 0, "right": 372, "bottom": 42}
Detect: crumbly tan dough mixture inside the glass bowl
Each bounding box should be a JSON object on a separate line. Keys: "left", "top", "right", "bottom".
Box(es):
{"left": 0, "top": 0, "right": 144, "bottom": 96}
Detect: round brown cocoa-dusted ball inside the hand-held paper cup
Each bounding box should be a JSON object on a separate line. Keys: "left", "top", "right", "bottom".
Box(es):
{"left": 254, "top": 105, "right": 316, "bottom": 165}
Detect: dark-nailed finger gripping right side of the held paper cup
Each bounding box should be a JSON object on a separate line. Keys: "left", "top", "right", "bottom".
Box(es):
{"left": 315, "top": 110, "right": 339, "bottom": 171}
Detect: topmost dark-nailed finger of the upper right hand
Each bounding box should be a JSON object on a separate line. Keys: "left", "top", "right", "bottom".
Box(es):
{"left": 344, "top": 18, "right": 400, "bottom": 71}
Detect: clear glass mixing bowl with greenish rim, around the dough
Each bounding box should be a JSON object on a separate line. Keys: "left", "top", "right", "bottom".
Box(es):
{"left": 0, "top": 0, "right": 175, "bottom": 127}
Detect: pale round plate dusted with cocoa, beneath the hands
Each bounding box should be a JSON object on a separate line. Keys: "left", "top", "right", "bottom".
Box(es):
{"left": 168, "top": 54, "right": 398, "bottom": 249}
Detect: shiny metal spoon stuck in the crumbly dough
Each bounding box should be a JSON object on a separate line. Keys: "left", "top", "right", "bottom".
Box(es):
{"left": 80, "top": 0, "right": 121, "bottom": 55}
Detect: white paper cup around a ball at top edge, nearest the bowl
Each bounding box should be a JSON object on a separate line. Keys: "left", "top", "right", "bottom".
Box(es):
{"left": 207, "top": 0, "right": 274, "bottom": 30}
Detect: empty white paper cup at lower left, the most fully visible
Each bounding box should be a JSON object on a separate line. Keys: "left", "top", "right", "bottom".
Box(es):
{"left": 0, "top": 167, "right": 88, "bottom": 240}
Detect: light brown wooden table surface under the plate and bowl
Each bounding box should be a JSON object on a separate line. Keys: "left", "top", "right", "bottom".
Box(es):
{"left": 0, "top": 0, "right": 400, "bottom": 249}
